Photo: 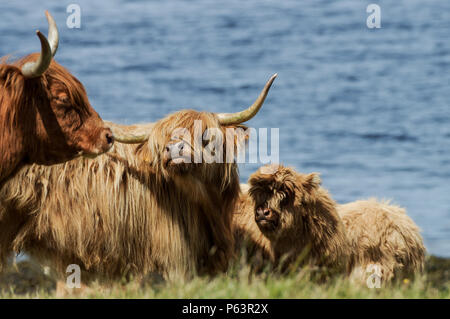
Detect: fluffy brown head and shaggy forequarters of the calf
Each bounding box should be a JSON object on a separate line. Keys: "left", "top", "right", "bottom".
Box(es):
{"left": 233, "top": 165, "right": 349, "bottom": 269}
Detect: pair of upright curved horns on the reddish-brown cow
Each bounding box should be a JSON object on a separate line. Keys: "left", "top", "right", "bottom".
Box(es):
{"left": 22, "top": 11, "right": 59, "bottom": 78}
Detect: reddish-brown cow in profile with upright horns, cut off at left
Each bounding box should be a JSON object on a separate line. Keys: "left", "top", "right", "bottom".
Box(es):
{"left": 0, "top": 12, "right": 114, "bottom": 184}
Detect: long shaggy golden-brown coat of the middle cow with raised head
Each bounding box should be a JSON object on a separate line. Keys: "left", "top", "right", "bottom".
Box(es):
{"left": 0, "top": 110, "right": 246, "bottom": 282}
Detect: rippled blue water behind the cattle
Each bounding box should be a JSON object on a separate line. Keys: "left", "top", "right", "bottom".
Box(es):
{"left": 0, "top": 0, "right": 450, "bottom": 256}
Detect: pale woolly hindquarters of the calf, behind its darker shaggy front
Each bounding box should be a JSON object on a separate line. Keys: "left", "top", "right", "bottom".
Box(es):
{"left": 338, "top": 199, "right": 425, "bottom": 281}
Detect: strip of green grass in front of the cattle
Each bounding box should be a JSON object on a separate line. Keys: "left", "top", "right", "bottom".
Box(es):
{"left": 0, "top": 256, "right": 450, "bottom": 299}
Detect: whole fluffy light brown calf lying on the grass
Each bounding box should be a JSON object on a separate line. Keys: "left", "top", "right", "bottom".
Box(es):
{"left": 233, "top": 165, "right": 425, "bottom": 281}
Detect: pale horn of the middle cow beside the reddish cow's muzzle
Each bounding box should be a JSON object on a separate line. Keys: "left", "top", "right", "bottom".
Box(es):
{"left": 104, "top": 121, "right": 154, "bottom": 144}
